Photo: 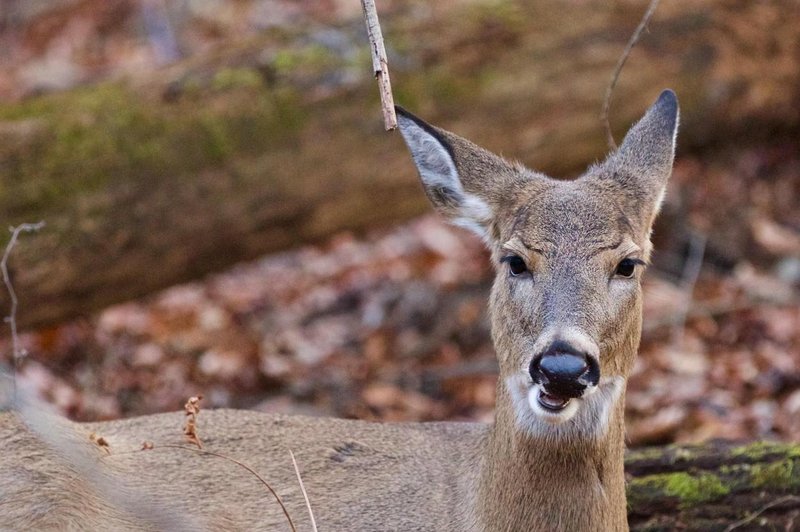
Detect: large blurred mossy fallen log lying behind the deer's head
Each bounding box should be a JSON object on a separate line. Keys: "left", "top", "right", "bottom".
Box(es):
{"left": 0, "top": 0, "right": 800, "bottom": 326}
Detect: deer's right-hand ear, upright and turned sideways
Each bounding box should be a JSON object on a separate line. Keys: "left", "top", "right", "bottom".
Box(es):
{"left": 606, "top": 89, "right": 678, "bottom": 223}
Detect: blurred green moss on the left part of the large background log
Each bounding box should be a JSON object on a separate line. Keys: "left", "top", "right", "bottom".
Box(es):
{"left": 0, "top": 79, "right": 304, "bottom": 219}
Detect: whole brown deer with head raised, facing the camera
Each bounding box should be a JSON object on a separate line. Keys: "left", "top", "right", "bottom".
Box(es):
{"left": 0, "top": 90, "right": 679, "bottom": 532}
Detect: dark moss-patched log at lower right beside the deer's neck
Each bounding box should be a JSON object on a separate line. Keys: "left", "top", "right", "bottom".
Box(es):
{"left": 625, "top": 442, "right": 800, "bottom": 532}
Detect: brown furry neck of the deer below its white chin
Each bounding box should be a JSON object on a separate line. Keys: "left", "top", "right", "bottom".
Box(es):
{"left": 476, "top": 380, "right": 627, "bottom": 531}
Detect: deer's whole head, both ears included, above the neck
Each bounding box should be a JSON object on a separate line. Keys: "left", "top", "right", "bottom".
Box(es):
{"left": 399, "top": 91, "right": 678, "bottom": 434}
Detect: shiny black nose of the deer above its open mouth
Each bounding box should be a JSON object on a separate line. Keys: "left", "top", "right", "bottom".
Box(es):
{"left": 530, "top": 342, "right": 600, "bottom": 398}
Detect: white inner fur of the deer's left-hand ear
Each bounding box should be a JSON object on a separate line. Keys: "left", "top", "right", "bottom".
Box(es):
{"left": 398, "top": 116, "right": 492, "bottom": 239}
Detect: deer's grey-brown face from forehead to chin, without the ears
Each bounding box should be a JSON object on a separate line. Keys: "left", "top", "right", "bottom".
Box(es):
{"left": 490, "top": 177, "right": 649, "bottom": 430}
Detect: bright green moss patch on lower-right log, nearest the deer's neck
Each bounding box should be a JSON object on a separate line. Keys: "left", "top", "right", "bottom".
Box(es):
{"left": 628, "top": 472, "right": 730, "bottom": 508}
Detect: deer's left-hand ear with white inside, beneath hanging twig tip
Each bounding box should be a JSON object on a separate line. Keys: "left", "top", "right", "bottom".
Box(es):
{"left": 396, "top": 107, "right": 516, "bottom": 239}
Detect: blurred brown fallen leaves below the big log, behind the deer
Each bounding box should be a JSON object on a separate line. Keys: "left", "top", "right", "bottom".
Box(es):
{"left": 7, "top": 206, "right": 800, "bottom": 446}
